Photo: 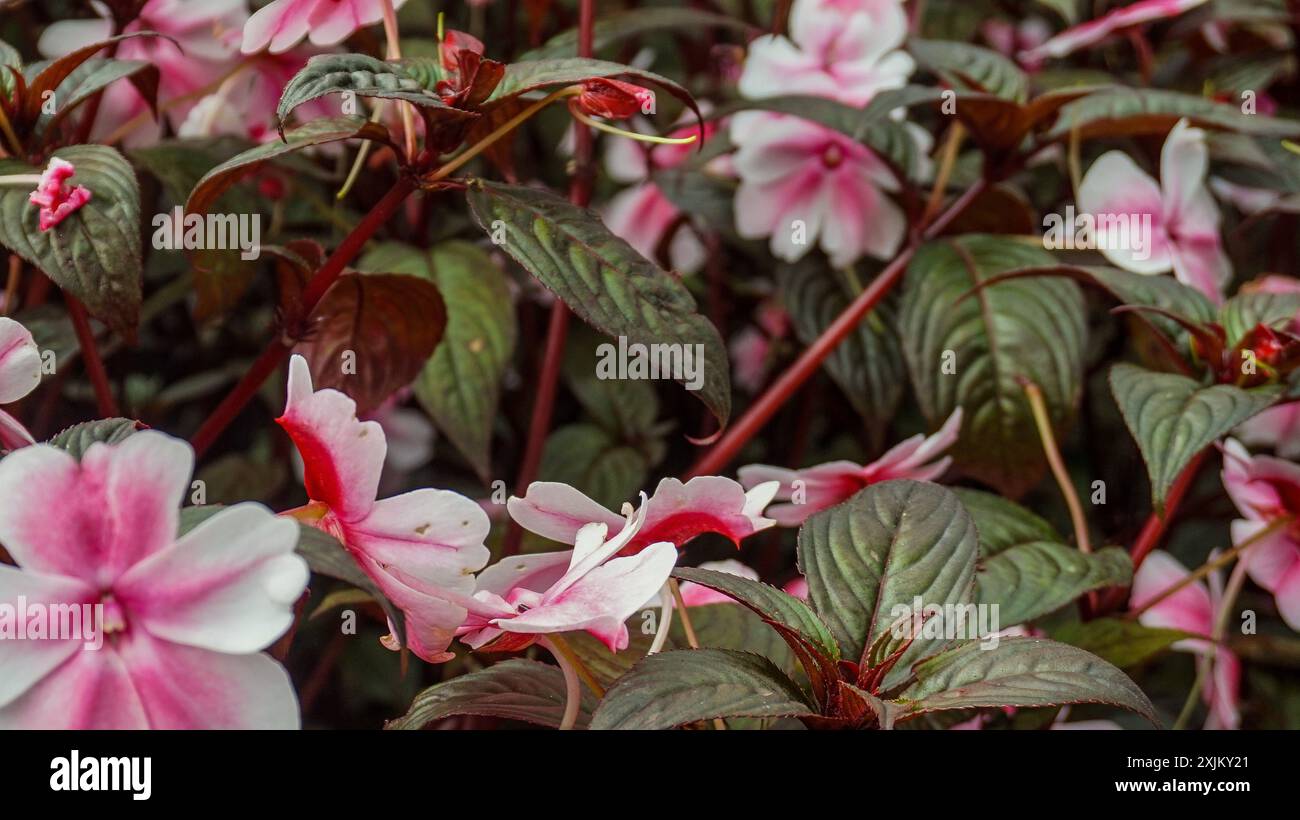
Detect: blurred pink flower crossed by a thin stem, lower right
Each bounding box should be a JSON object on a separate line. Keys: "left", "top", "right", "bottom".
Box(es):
{"left": 1130, "top": 550, "right": 1242, "bottom": 729}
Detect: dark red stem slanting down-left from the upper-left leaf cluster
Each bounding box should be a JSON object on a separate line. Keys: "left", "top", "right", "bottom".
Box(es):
{"left": 190, "top": 174, "right": 416, "bottom": 456}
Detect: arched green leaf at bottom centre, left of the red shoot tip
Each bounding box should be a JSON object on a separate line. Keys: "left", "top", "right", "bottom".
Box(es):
{"left": 592, "top": 648, "right": 815, "bottom": 729}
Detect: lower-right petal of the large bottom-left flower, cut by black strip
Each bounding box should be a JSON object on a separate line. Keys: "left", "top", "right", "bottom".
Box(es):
{"left": 115, "top": 632, "right": 302, "bottom": 729}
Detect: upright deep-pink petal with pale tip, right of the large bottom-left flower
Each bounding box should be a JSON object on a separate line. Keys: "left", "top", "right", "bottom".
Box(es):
{"left": 276, "top": 355, "right": 387, "bottom": 521}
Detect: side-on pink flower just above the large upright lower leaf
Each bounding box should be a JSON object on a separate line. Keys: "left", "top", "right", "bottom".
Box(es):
{"left": 738, "top": 407, "right": 962, "bottom": 526}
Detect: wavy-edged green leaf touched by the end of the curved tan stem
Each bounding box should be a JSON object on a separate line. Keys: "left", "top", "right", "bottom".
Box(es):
{"left": 975, "top": 541, "right": 1134, "bottom": 629}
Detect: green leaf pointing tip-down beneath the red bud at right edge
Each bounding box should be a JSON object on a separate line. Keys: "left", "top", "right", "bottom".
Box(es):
{"left": 1110, "top": 363, "right": 1282, "bottom": 509}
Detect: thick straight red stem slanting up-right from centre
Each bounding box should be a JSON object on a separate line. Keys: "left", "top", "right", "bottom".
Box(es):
{"left": 686, "top": 179, "right": 988, "bottom": 478}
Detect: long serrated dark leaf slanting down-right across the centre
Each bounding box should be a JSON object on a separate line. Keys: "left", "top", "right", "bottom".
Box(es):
{"left": 469, "top": 179, "right": 731, "bottom": 426}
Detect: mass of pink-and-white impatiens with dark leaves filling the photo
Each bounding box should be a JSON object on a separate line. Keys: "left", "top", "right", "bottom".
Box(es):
{"left": 0, "top": 0, "right": 1300, "bottom": 730}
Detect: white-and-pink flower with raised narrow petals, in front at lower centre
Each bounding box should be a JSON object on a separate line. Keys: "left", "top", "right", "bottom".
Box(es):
{"left": 458, "top": 504, "right": 677, "bottom": 652}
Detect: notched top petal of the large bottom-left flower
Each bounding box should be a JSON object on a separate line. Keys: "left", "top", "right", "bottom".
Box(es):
{"left": 0, "top": 430, "right": 194, "bottom": 589}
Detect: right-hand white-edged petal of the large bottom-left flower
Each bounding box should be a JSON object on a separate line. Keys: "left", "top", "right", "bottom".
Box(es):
{"left": 113, "top": 503, "right": 308, "bottom": 652}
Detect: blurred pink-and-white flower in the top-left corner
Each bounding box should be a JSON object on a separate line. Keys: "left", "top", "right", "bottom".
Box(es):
{"left": 38, "top": 0, "right": 248, "bottom": 144}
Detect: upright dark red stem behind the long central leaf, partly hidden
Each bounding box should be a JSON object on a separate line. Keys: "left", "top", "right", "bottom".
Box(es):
{"left": 502, "top": 0, "right": 595, "bottom": 555}
